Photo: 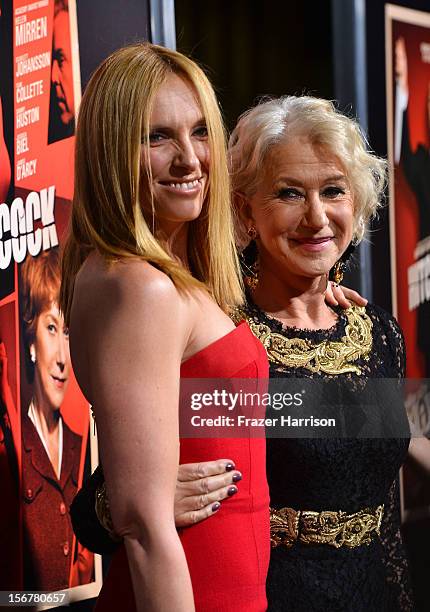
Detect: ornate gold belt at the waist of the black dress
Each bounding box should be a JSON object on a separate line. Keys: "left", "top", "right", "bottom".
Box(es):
{"left": 270, "top": 505, "right": 384, "bottom": 548}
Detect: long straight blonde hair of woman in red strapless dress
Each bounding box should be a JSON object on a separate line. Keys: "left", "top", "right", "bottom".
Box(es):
{"left": 60, "top": 43, "right": 242, "bottom": 323}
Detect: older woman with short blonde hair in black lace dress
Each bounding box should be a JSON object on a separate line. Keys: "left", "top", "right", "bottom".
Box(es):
{"left": 229, "top": 96, "right": 412, "bottom": 612}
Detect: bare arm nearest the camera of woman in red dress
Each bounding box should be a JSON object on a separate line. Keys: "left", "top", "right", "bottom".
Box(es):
{"left": 75, "top": 262, "right": 194, "bottom": 612}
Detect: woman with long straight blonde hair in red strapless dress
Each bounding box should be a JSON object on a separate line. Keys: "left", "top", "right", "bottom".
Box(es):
{"left": 61, "top": 44, "right": 269, "bottom": 612}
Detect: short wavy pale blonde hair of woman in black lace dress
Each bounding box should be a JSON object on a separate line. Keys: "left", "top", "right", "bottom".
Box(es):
{"left": 229, "top": 96, "right": 387, "bottom": 244}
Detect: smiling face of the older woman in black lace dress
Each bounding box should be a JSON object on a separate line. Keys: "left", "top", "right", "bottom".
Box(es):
{"left": 247, "top": 137, "right": 354, "bottom": 278}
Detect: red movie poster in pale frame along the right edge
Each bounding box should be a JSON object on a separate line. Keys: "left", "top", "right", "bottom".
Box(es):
{"left": 385, "top": 5, "right": 430, "bottom": 519}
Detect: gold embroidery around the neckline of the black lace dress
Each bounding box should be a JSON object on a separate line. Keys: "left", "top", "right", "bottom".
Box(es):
{"left": 232, "top": 306, "right": 373, "bottom": 374}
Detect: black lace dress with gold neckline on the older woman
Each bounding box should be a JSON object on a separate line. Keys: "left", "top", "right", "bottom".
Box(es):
{"left": 237, "top": 298, "right": 413, "bottom": 612}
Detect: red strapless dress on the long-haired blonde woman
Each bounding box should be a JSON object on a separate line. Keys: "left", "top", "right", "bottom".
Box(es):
{"left": 96, "top": 322, "right": 270, "bottom": 612}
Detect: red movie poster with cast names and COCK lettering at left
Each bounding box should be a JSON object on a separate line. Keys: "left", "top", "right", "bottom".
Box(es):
{"left": 0, "top": 0, "right": 101, "bottom": 607}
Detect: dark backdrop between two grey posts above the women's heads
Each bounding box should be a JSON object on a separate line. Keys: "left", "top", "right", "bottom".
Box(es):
{"left": 175, "top": 0, "right": 334, "bottom": 129}
